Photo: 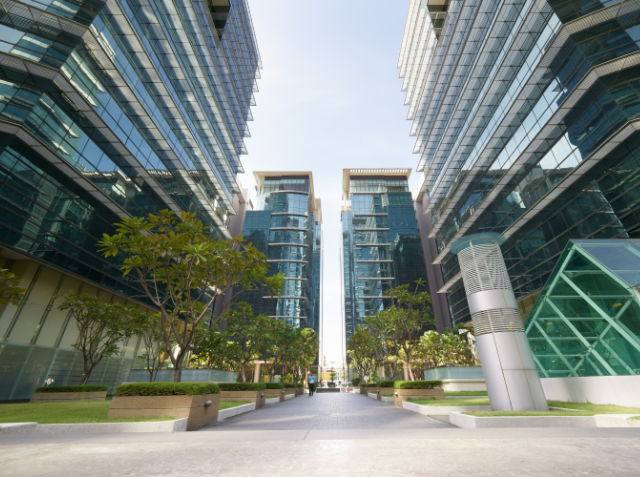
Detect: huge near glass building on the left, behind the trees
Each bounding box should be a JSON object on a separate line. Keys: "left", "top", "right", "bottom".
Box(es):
{"left": 0, "top": 0, "right": 261, "bottom": 400}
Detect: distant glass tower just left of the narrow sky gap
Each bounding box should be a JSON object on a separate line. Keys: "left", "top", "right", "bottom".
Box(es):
{"left": 239, "top": 172, "right": 323, "bottom": 334}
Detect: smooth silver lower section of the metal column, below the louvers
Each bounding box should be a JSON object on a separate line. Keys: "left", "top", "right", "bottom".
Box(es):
{"left": 476, "top": 332, "right": 549, "bottom": 411}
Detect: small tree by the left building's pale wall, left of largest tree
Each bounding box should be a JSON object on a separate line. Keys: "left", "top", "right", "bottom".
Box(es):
{"left": 56, "top": 290, "right": 148, "bottom": 384}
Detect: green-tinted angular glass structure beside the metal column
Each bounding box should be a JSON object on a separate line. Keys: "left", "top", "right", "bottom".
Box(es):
{"left": 525, "top": 239, "right": 640, "bottom": 378}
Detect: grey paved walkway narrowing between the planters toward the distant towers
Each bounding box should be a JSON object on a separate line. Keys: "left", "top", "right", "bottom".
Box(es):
{"left": 201, "top": 393, "right": 451, "bottom": 431}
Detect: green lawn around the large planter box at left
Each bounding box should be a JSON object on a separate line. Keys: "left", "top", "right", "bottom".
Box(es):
{"left": 0, "top": 400, "right": 249, "bottom": 424}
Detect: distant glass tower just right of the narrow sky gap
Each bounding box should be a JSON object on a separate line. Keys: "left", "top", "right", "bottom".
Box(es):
{"left": 341, "top": 169, "right": 427, "bottom": 339}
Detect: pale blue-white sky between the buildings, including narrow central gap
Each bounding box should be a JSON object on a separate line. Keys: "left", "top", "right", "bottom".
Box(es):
{"left": 240, "top": 0, "right": 419, "bottom": 361}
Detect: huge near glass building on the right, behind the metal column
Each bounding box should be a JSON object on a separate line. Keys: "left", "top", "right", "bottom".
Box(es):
{"left": 399, "top": 0, "right": 640, "bottom": 375}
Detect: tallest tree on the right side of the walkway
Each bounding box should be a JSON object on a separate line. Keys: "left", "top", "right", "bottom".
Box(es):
{"left": 377, "top": 279, "right": 435, "bottom": 381}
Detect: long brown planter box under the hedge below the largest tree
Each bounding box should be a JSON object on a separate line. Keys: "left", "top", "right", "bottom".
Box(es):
{"left": 107, "top": 394, "right": 220, "bottom": 431}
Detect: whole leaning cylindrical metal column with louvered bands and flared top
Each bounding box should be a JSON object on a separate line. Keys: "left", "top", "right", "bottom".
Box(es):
{"left": 451, "top": 233, "right": 548, "bottom": 411}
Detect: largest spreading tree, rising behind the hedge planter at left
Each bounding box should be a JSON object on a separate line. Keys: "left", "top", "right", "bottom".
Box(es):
{"left": 99, "top": 210, "right": 284, "bottom": 382}
